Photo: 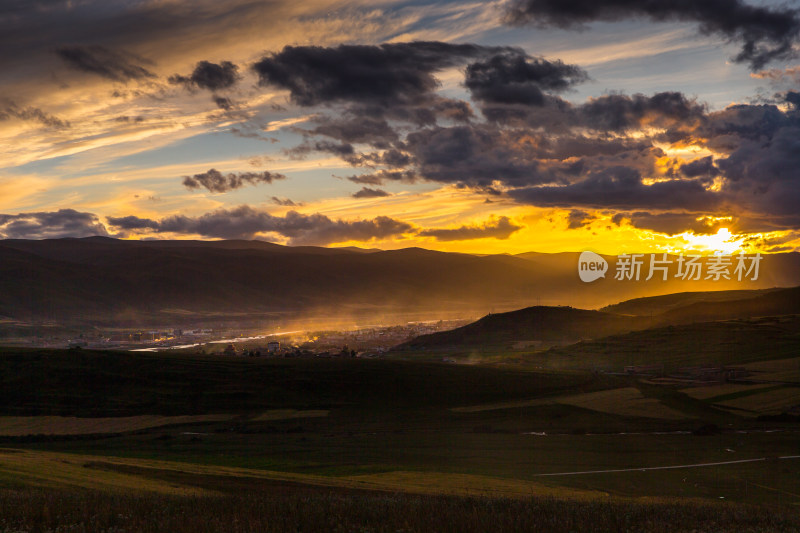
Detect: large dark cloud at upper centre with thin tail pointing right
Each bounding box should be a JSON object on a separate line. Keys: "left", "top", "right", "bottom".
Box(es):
{"left": 253, "top": 42, "right": 521, "bottom": 108}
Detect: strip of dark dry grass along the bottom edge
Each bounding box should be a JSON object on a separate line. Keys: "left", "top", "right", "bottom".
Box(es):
{"left": 0, "top": 487, "right": 800, "bottom": 533}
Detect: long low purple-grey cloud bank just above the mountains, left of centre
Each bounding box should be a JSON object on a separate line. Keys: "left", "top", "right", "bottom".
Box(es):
{"left": 108, "top": 205, "right": 413, "bottom": 245}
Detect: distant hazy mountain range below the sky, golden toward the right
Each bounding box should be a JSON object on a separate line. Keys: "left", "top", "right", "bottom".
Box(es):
{"left": 0, "top": 237, "right": 800, "bottom": 325}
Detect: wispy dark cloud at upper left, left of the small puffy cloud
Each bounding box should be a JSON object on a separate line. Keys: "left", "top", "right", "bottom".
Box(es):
{"left": 55, "top": 46, "right": 155, "bottom": 82}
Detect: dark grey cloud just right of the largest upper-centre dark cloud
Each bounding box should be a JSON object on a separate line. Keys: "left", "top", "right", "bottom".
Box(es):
{"left": 464, "top": 53, "right": 588, "bottom": 105}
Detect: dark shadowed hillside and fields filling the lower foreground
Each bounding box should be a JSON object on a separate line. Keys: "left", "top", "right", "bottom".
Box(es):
{"left": 0, "top": 349, "right": 800, "bottom": 531}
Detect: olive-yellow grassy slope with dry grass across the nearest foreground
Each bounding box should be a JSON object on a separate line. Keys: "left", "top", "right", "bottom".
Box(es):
{"left": 0, "top": 450, "right": 800, "bottom": 533}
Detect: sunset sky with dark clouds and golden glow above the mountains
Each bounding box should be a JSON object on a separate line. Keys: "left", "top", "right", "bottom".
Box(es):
{"left": 0, "top": 0, "right": 800, "bottom": 254}
